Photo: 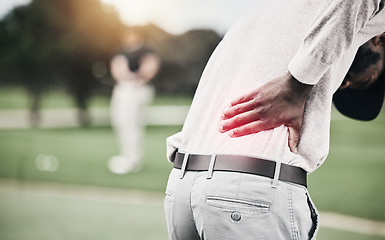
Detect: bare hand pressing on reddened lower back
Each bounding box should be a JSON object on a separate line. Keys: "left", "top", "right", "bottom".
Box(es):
{"left": 219, "top": 72, "right": 313, "bottom": 153}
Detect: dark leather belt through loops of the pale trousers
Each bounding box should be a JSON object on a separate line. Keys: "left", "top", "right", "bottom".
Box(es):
{"left": 174, "top": 152, "right": 307, "bottom": 187}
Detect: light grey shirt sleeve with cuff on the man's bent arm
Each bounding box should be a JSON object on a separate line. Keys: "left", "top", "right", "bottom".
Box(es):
{"left": 288, "top": 0, "right": 383, "bottom": 85}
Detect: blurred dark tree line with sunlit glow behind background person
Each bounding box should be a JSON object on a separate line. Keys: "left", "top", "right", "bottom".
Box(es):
{"left": 0, "top": 0, "right": 221, "bottom": 126}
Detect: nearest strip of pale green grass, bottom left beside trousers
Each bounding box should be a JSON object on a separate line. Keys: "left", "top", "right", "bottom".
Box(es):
{"left": 0, "top": 188, "right": 167, "bottom": 240}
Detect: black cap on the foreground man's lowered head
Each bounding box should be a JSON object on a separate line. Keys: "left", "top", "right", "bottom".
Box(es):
{"left": 333, "top": 74, "right": 385, "bottom": 121}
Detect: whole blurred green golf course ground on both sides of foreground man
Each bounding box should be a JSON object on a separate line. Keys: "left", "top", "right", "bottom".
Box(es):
{"left": 0, "top": 87, "right": 385, "bottom": 240}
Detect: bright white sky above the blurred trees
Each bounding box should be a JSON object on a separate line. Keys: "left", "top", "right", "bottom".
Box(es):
{"left": 0, "top": 0, "right": 258, "bottom": 34}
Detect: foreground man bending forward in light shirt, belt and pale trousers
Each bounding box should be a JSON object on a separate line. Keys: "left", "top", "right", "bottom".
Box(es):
{"left": 165, "top": 0, "right": 385, "bottom": 240}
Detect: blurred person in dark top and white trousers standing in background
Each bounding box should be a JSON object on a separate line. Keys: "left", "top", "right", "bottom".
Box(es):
{"left": 108, "top": 30, "right": 160, "bottom": 174}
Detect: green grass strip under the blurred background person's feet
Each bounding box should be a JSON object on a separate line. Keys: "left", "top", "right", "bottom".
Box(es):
{"left": 0, "top": 127, "right": 180, "bottom": 191}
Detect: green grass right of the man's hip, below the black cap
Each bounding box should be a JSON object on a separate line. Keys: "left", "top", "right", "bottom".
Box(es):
{"left": 309, "top": 114, "right": 385, "bottom": 220}
